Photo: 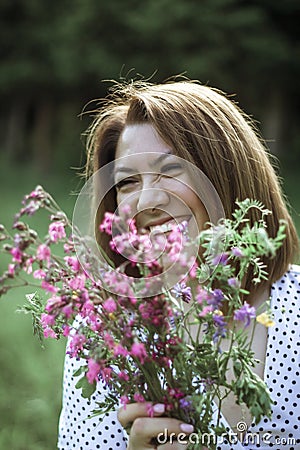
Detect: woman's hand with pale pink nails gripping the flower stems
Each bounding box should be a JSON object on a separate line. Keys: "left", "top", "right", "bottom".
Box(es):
{"left": 118, "top": 402, "right": 194, "bottom": 450}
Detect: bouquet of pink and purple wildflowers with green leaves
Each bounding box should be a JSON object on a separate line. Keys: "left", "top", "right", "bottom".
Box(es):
{"left": 0, "top": 186, "right": 285, "bottom": 449}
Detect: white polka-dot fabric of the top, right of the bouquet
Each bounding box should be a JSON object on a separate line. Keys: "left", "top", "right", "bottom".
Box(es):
{"left": 217, "top": 266, "right": 300, "bottom": 450}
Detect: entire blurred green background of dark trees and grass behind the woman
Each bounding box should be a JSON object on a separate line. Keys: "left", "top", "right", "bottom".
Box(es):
{"left": 0, "top": 0, "right": 300, "bottom": 450}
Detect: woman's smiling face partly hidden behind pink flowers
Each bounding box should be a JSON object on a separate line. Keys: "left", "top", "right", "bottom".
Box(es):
{"left": 114, "top": 123, "right": 208, "bottom": 237}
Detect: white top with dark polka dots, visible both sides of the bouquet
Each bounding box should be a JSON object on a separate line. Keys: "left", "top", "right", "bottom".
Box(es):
{"left": 58, "top": 266, "right": 300, "bottom": 450}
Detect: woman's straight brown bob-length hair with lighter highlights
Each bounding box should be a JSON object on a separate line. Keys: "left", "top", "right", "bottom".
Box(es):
{"left": 86, "top": 80, "right": 298, "bottom": 295}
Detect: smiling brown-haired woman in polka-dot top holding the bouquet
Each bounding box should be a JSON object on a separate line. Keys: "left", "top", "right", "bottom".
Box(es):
{"left": 59, "top": 81, "right": 300, "bottom": 450}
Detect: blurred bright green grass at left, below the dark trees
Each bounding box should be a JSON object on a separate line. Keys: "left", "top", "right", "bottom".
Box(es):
{"left": 0, "top": 165, "right": 78, "bottom": 450}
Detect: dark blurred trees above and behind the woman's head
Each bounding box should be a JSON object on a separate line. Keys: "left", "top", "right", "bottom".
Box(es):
{"left": 0, "top": 0, "right": 300, "bottom": 171}
